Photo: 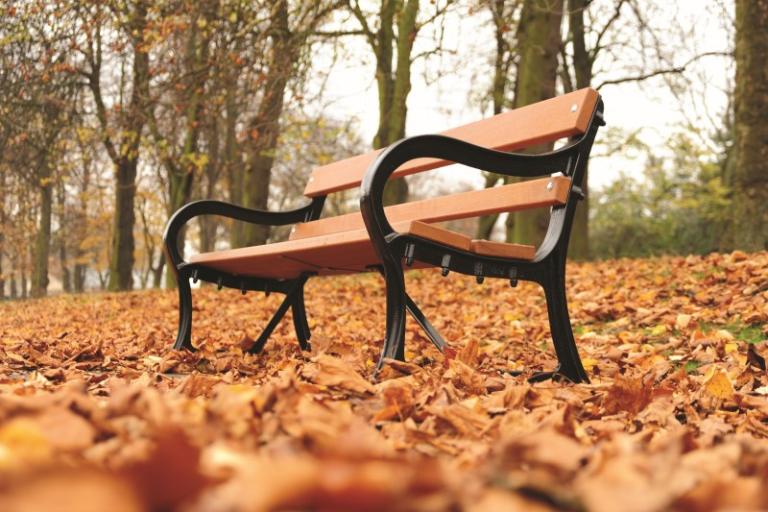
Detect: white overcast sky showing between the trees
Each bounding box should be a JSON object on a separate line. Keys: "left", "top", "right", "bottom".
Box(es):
{"left": 316, "top": 0, "right": 733, "bottom": 192}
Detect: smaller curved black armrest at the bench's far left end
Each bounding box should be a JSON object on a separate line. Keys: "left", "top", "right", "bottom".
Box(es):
{"left": 163, "top": 197, "right": 325, "bottom": 270}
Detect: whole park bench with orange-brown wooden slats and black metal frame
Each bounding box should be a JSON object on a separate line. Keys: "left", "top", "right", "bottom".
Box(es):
{"left": 164, "top": 89, "right": 604, "bottom": 382}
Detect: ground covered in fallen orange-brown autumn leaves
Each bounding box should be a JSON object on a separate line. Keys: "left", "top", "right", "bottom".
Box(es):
{"left": 0, "top": 253, "right": 768, "bottom": 512}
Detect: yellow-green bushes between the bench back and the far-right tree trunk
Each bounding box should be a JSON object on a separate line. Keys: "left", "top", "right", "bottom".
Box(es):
{"left": 590, "top": 132, "right": 730, "bottom": 258}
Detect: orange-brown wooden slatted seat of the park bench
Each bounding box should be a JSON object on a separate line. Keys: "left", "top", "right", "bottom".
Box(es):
{"left": 189, "top": 221, "right": 536, "bottom": 279}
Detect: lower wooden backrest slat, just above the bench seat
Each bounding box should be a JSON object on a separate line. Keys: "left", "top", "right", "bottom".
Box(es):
{"left": 290, "top": 176, "right": 571, "bottom": 240}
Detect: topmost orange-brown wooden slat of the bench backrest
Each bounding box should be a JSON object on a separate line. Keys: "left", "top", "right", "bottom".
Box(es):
{"left": 304, "top": 89, "right": 598, "bottom": 197}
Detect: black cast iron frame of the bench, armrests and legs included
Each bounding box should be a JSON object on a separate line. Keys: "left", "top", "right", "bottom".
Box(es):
{"left": 164, "top": 100, "right": 605, "bottom": 382}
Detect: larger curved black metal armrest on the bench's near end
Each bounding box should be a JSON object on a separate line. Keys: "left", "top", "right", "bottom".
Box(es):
{"left": 360, "top": 135, "right": 580, "bottom": 245}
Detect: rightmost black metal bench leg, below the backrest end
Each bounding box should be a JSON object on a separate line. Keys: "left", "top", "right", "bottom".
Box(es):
{"left": 542, "top": 268, "right": 589, "bottom": 382}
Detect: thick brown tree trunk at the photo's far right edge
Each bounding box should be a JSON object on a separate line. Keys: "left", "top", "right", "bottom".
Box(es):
{"left": 732, "top": 0, "right": 768, "bottom": 251}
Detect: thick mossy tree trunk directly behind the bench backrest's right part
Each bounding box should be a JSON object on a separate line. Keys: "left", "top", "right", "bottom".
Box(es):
{"left": 507, "top": 0, "right": 563, "bottom": 245}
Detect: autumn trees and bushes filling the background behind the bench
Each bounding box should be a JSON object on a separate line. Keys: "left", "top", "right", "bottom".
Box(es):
{"left": 0, "top": 0, "right": 768, "bottom": 298}
